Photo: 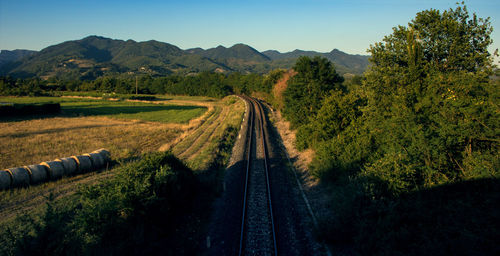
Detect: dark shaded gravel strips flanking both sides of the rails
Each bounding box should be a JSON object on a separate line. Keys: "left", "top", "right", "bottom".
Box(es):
{"left": 201, "top": 99, "right": 323, "bottom": 255}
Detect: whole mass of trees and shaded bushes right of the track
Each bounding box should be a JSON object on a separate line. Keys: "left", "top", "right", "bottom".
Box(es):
{"left": 284, "top": 6, "right": 500, "bottom": 255}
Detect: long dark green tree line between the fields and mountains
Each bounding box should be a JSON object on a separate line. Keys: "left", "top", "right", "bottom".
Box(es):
{"left": 0, "top": 71, "right": 279, "bottom": 98}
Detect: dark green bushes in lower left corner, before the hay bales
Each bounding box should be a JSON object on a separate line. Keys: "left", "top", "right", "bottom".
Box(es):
{"left": 0, "top": 152, "right": 198, "bottom": 255}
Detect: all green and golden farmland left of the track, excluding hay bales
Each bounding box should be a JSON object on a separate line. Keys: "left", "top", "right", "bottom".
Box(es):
{"left": 0, "top": 96, "right": 245, "bottom": 223}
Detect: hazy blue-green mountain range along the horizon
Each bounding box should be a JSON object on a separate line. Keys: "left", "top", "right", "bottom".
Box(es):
{"left": 0, "top": 36, "right": 369, "bottom": 79}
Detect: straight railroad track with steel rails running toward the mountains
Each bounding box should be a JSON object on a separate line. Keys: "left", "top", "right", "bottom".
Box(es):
{"left": 238, "top": 96, "right": 278, "bottom": 255}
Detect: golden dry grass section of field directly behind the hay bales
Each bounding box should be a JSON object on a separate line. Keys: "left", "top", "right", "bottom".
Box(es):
{"left": 0, "top": 117, "right": 183, "bottom": 168}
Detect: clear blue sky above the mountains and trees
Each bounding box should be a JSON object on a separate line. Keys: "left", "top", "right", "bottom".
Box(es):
{"left": 0, "top": 0, "right": 500, "bottom": 57}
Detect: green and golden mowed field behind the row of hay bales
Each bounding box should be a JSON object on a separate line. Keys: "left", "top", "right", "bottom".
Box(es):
{"left": 0, "top": 97, "right": 211, "bottom": 168}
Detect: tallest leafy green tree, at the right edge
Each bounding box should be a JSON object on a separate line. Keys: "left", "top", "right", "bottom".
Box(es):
{"left": 364, "top": 2, "right": 499, "bottom": 185}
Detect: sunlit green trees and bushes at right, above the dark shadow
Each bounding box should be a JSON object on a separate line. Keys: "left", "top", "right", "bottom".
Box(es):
{"left": 306, "top": 5, "right": 500, "bottom": 188}
